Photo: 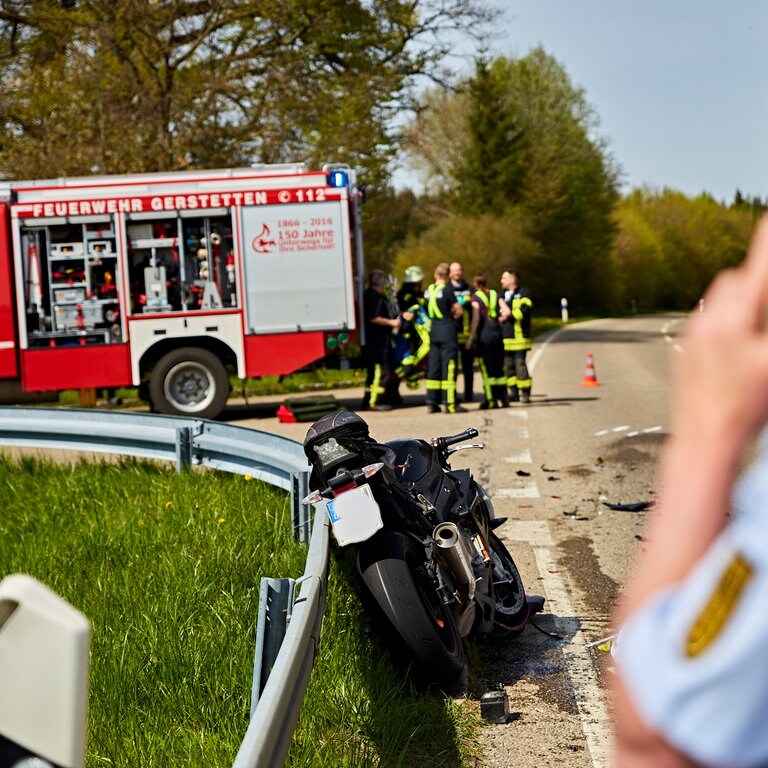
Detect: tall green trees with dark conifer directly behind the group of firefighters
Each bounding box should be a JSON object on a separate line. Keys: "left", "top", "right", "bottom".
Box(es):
{"left": 396, "top": 49, "right": 618, "bottom": 312}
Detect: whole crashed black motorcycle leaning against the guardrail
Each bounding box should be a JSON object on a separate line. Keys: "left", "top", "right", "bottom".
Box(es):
{"left": 304, "top": 411, "right": 541, "bottom": 685}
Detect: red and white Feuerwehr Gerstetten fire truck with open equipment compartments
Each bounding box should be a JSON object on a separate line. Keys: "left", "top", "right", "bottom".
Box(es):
{"left": 0, "top": 164, "right": 363, "bottom": 418}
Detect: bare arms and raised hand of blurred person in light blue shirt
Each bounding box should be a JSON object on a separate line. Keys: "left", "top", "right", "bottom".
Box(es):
{"left": 612, "top": 219, "right": 768, "bottom": 768}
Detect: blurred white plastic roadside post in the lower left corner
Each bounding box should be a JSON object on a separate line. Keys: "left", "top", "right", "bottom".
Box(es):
{"left": 0, "top": 574, "right": 90, "bottom": 768}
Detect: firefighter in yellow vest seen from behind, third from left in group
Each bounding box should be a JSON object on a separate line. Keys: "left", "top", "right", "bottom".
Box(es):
{"left": 425, "top": 263, "right": 464, "bottom": 413}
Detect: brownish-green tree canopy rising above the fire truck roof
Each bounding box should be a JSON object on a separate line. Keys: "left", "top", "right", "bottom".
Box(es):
{"left": 0, "top": 0, "right": 495, "bottom": 186}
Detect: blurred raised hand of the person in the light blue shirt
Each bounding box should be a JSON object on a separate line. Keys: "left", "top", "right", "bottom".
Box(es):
{"left": 673, "top": 217, "right": 768, "bottom": 451}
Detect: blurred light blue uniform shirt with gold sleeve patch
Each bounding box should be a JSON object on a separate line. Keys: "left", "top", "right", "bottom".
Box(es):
{"left": 615, "top": 437, "right": 768, "bottom": 768}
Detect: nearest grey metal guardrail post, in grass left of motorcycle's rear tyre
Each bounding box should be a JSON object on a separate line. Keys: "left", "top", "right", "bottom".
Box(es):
{"left": 251, "top": 578, "right": 296, "bottom": 717}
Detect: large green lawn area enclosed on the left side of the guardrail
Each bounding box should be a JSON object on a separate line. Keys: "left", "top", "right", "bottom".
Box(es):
{"left": 0, "top": 458, "right": 306, "bottom": 766}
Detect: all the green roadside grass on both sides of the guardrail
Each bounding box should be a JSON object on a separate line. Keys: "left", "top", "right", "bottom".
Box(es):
{"left": 0, "top": 456, "right": 478, "bottom": 768}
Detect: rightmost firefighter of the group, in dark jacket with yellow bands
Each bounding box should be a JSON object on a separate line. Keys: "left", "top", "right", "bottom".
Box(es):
{"left": 501, "top": 269, "right": 533, "bottom": 403}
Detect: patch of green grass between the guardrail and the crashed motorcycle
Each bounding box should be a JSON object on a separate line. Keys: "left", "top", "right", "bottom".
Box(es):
{"left": 286, "top": 553, "right": 480, "bottom": 768}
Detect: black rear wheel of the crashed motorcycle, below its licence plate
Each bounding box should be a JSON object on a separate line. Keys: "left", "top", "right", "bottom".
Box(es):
{"left": 358, "top": 531, "right": 465, "bottom": 685}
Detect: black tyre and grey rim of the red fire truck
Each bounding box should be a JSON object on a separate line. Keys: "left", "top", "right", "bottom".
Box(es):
{"left": 149, "top": 347, "right": 229, "bottom": 419}
